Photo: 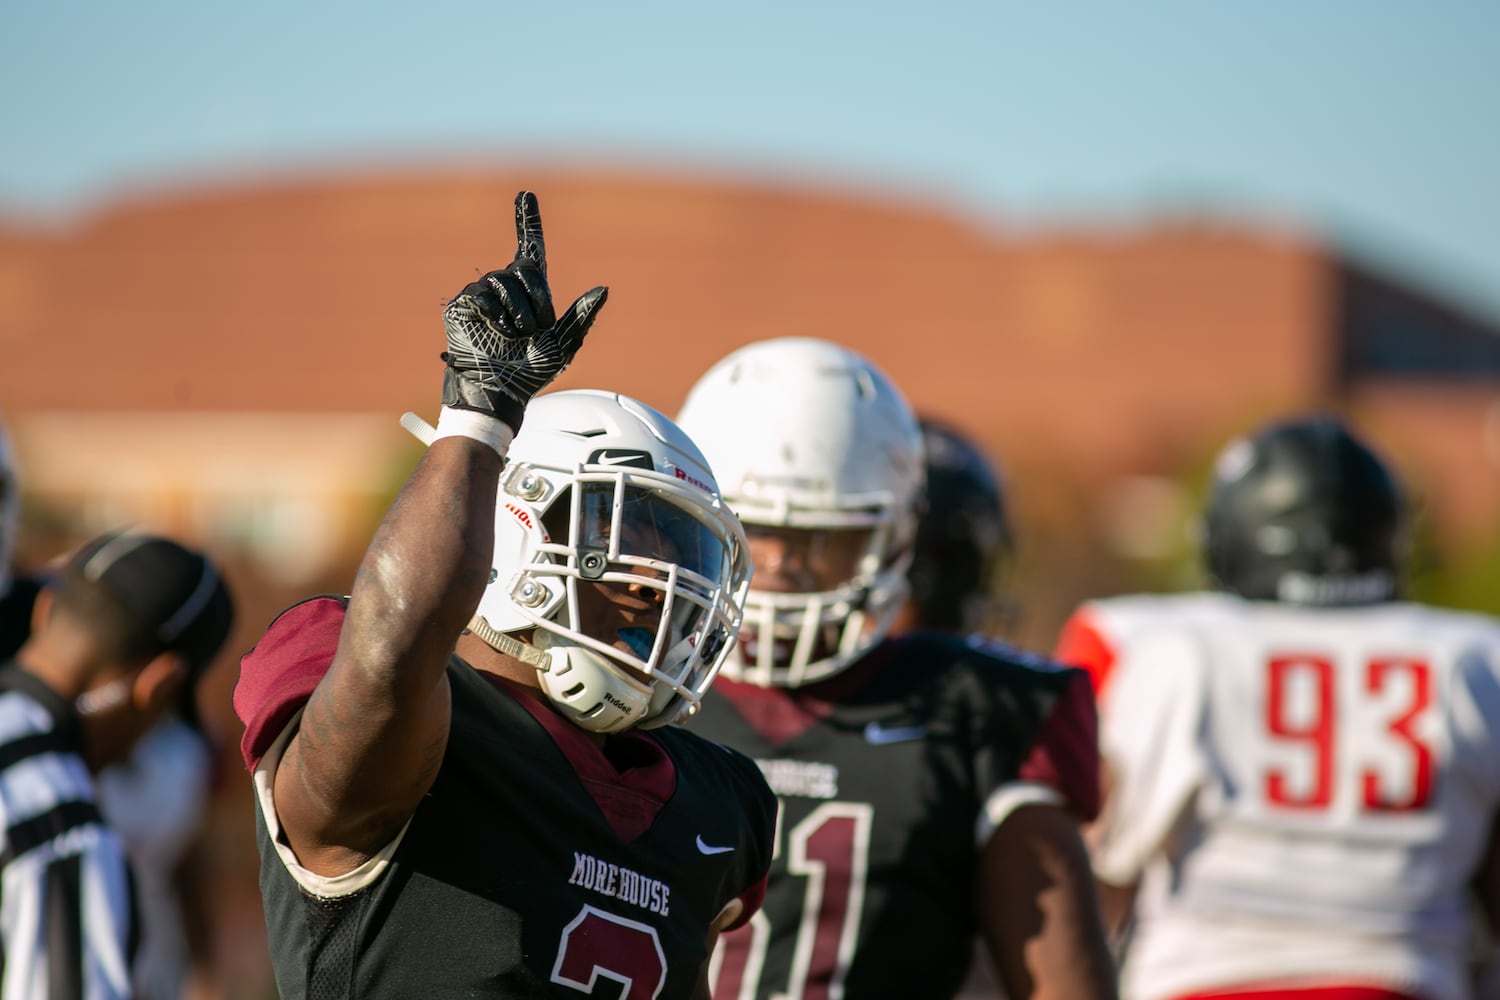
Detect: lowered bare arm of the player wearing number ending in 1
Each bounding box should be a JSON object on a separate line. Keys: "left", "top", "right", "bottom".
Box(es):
{"left": 978, "top": 804, "right": 1118, "bottom": 1000}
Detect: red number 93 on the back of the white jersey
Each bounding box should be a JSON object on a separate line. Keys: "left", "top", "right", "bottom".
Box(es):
{"left": 1265, "top": 655, "right": 1433, "bottom": 813}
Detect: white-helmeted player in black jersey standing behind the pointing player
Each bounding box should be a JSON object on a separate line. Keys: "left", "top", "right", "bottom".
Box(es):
{"left": 678, "top": 337, "right": 1113, "bottom": 1000}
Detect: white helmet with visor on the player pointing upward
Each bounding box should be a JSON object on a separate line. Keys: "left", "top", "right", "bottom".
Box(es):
{"left": 444, "top": 390, "right": 750, "bottom": 733}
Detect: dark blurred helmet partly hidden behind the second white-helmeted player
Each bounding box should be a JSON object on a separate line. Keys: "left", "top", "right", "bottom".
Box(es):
{"left": 908, "top": 417, "right": 1014, "bottom": 631}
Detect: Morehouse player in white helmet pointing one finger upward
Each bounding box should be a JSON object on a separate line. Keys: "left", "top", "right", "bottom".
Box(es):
{"left": 236, "top": 192, "right": 776, "bottom": 1000}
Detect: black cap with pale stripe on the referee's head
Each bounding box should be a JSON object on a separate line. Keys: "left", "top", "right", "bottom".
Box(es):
{"left": 74, "top": 531, "right": 234, "bottom": 726}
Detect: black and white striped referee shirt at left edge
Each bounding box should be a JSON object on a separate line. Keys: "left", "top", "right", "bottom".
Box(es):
{"left": 0, "top": 664, "right": 137, "bottom": 1000}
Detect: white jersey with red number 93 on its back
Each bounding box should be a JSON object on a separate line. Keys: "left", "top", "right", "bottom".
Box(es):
{"left": 1095, "top": 595, "right": 1500, "bottom": 997}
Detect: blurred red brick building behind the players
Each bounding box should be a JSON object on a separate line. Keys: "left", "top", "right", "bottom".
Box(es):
{"left": 0, "top": 171, "right": 1500, "bottom": 995}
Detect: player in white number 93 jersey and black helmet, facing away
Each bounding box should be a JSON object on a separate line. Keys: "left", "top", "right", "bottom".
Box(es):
{"left": 1058, "top": 417, "right": 1500, "bottom": 1000}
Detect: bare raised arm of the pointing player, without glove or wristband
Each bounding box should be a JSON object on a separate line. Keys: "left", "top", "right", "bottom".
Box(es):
{"left": 275, "top": 438, "right": 501, "bottom": 874}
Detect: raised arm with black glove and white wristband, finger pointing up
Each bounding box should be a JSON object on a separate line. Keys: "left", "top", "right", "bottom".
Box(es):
{"left": 275, "top": 192, "right": 606, "bottom": 876}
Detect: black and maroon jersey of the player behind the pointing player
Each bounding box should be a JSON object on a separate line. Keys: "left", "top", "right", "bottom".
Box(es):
{"left": 692, "top": 633, "right": 1098, "bottom": 1000}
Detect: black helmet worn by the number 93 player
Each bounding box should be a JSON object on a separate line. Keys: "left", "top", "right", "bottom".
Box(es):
{"left": 1203, "top": 415, "right": 1406, "bottom": 604}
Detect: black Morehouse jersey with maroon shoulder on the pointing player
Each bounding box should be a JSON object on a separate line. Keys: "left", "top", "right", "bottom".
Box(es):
{"left": 236, "top": 598, "right": 776, "bottom": 1000}
